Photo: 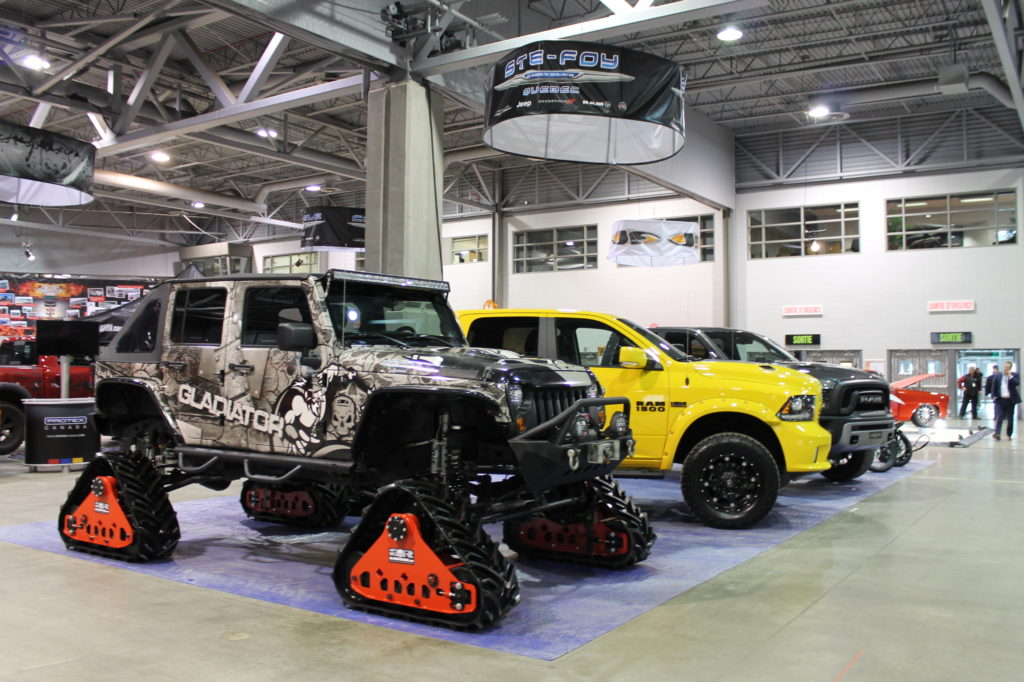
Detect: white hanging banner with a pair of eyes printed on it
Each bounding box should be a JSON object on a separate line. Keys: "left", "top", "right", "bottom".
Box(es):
{"left": 608, "top": 220, "right": 700, "bottom": 267}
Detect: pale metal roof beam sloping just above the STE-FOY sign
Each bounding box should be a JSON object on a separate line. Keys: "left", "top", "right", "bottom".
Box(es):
{"left": 412, "top": 0, "right": 768, "bottom": 76}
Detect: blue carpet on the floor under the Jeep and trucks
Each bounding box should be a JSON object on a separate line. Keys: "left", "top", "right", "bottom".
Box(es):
{"left": 0, "top": 462, "right": 931, "bottom": 660}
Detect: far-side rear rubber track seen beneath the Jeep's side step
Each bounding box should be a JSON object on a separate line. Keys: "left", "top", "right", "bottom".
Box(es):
{"left": 239, "top": 480, "right": 350, "bottom": 528}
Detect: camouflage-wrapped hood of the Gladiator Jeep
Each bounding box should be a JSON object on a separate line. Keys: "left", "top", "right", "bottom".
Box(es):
{"left": 338, "top": 346, "right": 594, "bottom": 387}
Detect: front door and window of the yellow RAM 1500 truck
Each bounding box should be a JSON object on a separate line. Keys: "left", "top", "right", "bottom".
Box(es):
{"left": 554, "top": 316, "right": 670, "bottom": 466}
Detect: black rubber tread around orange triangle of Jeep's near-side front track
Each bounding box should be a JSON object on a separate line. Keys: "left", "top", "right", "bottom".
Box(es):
{"left": 334, "top": 480, "right": 519, "bottom": 630}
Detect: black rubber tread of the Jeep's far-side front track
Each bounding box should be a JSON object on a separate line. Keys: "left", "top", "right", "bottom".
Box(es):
{"left": 504, "top": 475, "right": 657, "bottom": 568}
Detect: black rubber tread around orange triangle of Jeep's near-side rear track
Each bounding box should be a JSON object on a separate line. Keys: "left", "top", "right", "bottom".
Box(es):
{"left": 57, "top": 453, "right": 181, "bottom": 562}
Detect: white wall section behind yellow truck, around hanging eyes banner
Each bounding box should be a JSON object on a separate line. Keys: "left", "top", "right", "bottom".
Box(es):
{"left": 493, "top": 199, "right": 724, "bottom": 326}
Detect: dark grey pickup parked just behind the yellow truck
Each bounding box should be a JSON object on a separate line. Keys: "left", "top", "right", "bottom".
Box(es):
{"left": 651, "top": 327, "right": 894, "bottom": 480}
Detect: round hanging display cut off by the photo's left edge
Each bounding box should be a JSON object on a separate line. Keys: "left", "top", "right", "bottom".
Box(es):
{"left": 0, "top": 121, "right": 96, "bottom": 206}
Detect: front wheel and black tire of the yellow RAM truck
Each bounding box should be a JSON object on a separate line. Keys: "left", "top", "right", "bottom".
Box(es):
{"left": 680, "top": 433, "right": 779, "bottom": 528}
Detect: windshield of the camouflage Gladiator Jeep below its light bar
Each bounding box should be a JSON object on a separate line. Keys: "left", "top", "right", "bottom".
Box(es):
{"left": 327, "top": 280, "right": 466, "bottom": 347}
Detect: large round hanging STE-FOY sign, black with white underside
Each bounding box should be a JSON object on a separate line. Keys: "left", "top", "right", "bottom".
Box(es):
{"left": 483, "top": 40, "right": 686, "bottom": 165}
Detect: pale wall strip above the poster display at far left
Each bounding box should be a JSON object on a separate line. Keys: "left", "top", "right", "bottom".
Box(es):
{"left": 0, "top": 227, "right": 178, "bottom": 278}
